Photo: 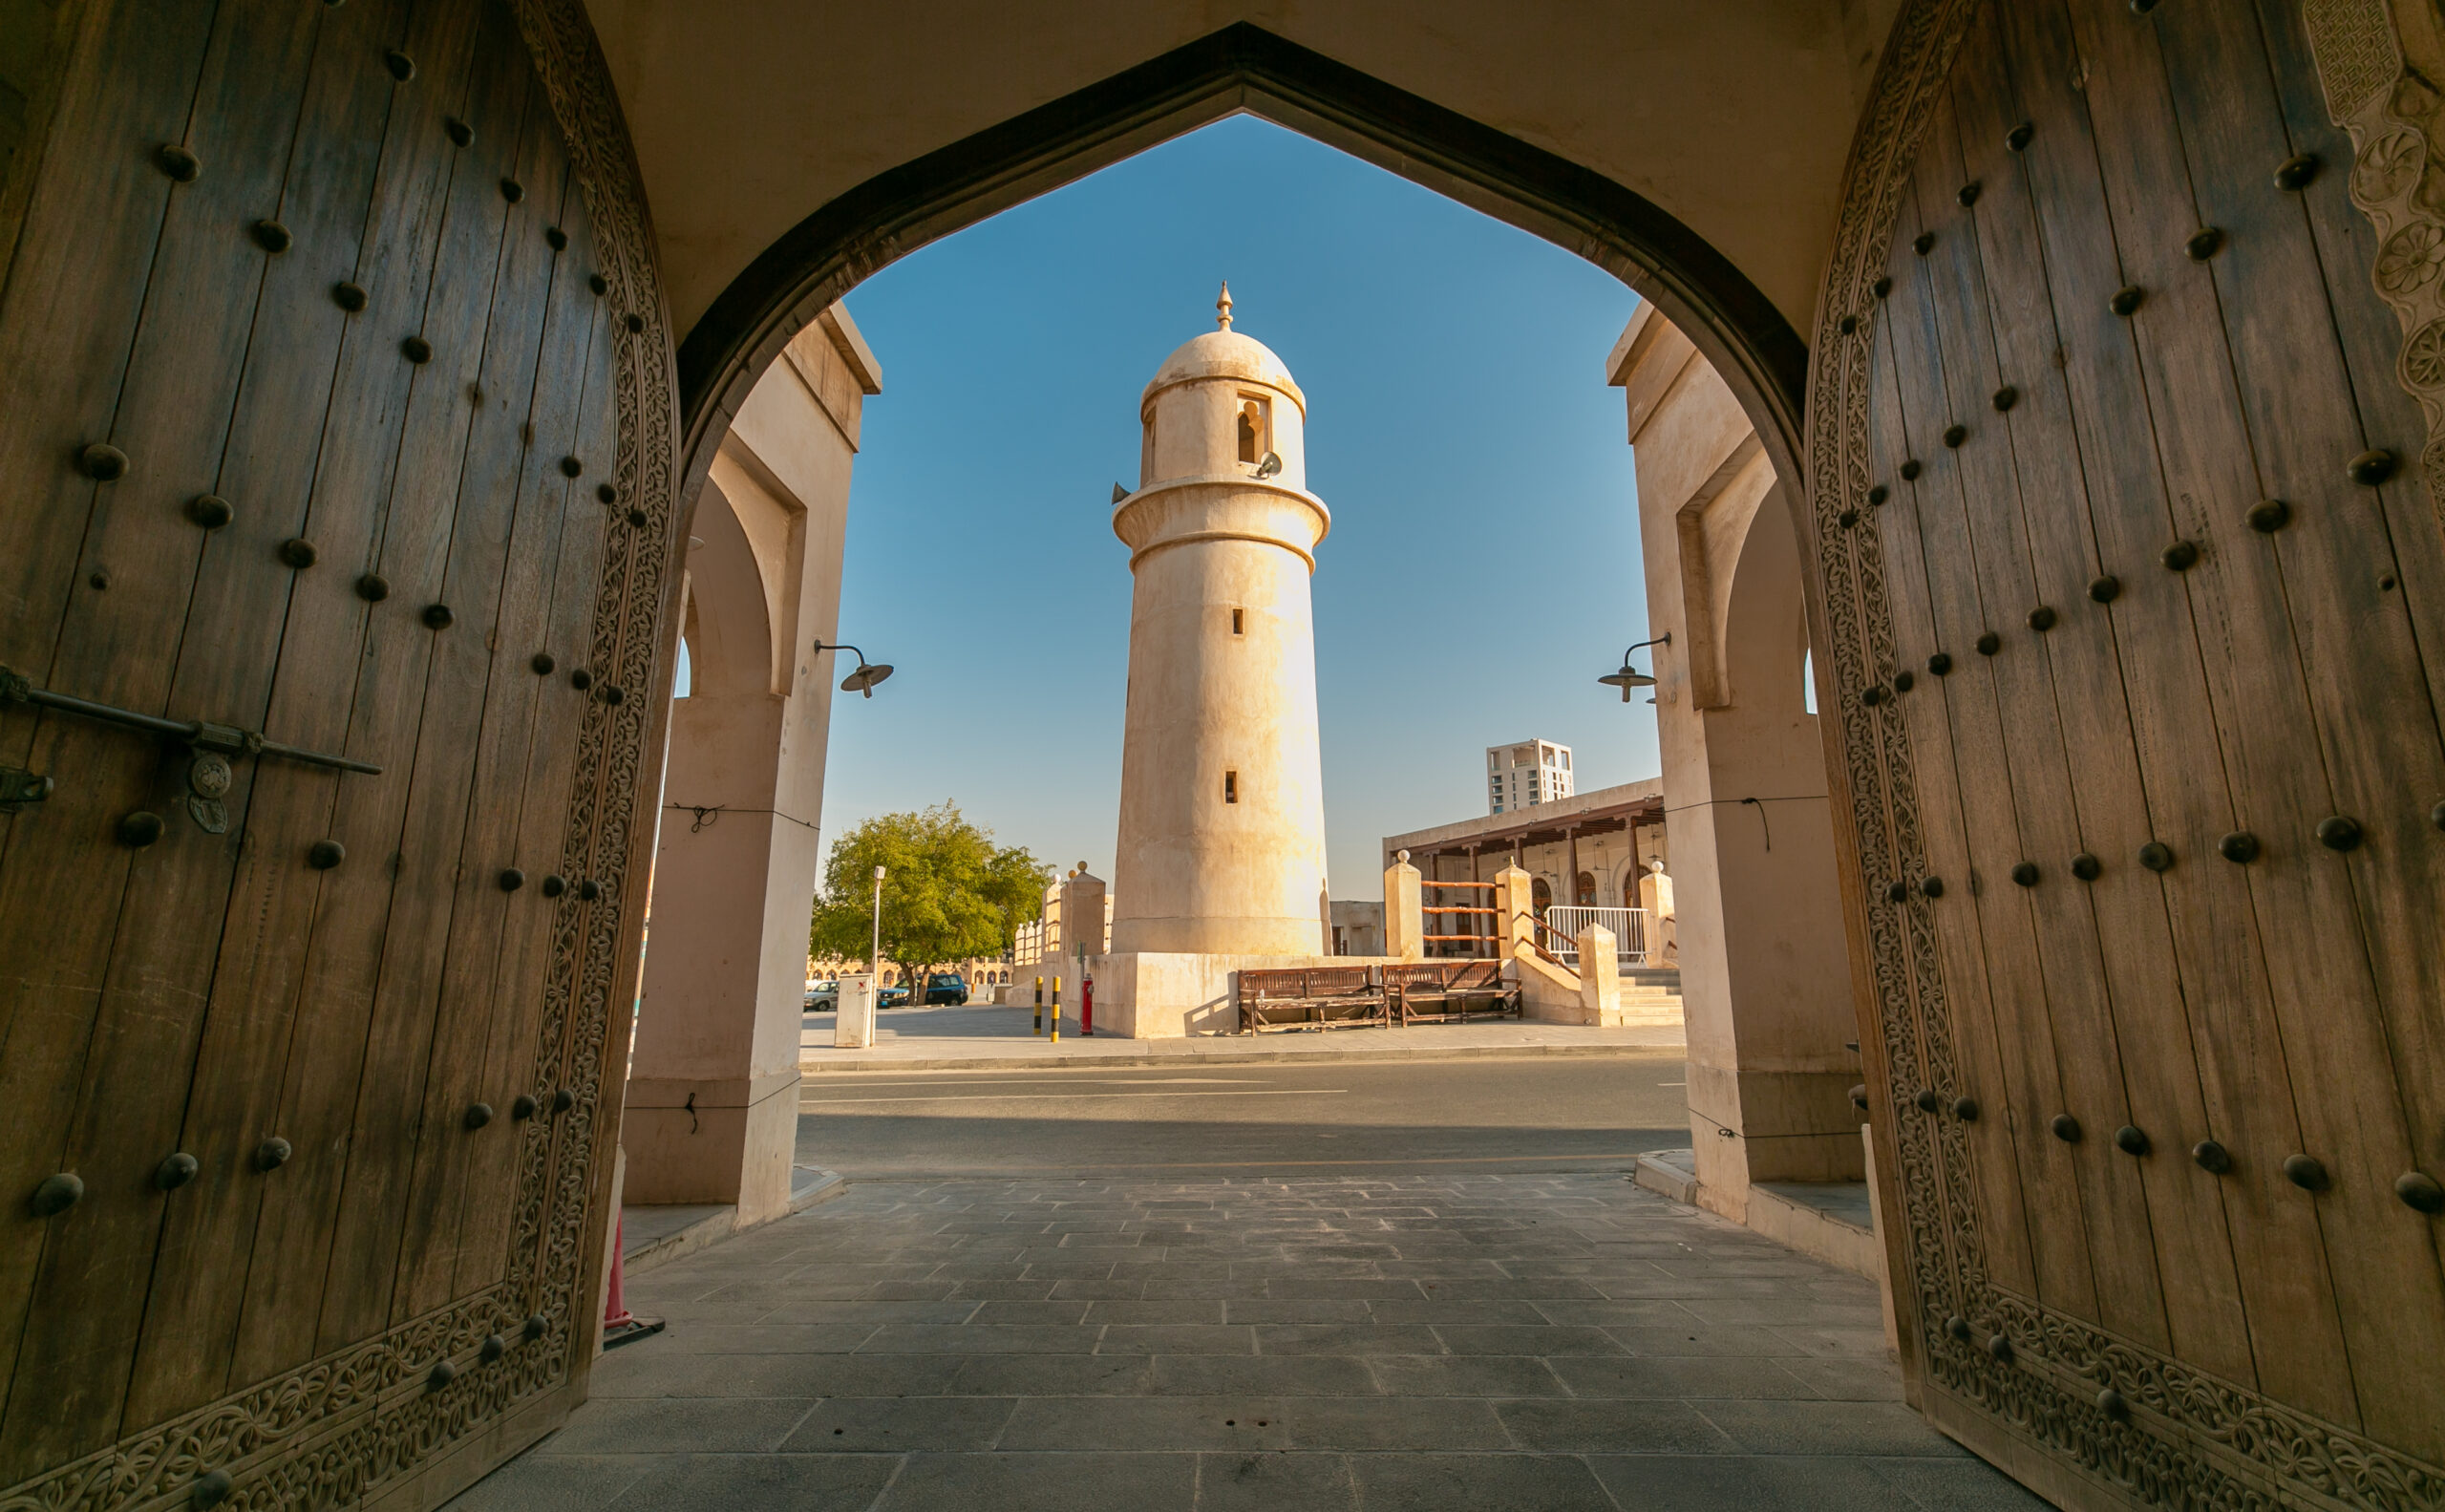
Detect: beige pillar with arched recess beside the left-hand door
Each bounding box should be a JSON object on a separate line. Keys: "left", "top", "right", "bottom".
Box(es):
{"left": 621, "top": 309, "right": 881, "bottom": 1224}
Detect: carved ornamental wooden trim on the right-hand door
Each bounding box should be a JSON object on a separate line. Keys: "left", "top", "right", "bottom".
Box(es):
{"left": 1807, "top": 0, "right": 2445, "bottom": 1512}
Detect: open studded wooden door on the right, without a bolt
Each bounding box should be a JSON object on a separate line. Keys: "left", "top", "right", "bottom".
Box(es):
{"left": 1809, "top": 0, "right": 2445, "bottom": 1509}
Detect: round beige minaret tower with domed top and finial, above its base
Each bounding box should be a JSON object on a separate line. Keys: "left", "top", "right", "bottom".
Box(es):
{"left": 1113, "top": 284, "right": 1332, "bottom": 954}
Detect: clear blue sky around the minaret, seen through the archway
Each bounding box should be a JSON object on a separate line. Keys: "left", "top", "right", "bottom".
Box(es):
{"left": 821, "top": 117, "right": 1658, "bottom": 898}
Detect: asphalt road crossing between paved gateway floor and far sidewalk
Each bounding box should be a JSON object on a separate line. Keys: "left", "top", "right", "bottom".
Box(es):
{"left": 797, "top": 1054, "right": 1690, "bottom": 1182}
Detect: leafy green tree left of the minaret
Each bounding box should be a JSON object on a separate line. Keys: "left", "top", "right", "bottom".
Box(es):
{"left": 807, "top": 802, "right": 1052, "bottom": 1003}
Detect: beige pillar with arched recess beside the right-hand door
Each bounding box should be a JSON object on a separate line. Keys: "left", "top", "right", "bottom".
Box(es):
{"left": 1608, "top": 306, "right": 1860, "bottom": 1219}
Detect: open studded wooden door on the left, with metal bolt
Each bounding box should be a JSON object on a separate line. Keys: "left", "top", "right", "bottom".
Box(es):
{"left": 0, "top": 0, "right": 672, "bottom": 1509}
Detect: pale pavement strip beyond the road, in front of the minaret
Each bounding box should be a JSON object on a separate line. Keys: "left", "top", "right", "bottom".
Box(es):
{"left": 797, "top": 1006, "right": 1687, "bottom": 1074}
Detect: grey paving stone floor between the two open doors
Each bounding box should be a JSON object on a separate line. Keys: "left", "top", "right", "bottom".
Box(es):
{"left": 453, "top": 1172, "right": 2044, "bottom": 1512}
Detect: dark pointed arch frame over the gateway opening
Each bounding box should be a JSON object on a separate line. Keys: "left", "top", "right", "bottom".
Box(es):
{"left": 677, "top": 22, "right": 1809, "bottom": 530}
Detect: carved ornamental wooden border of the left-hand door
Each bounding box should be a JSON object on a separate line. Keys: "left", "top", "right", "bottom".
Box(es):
{"left": 0, "top": 0, "right": 680, "bottom": 1512}
